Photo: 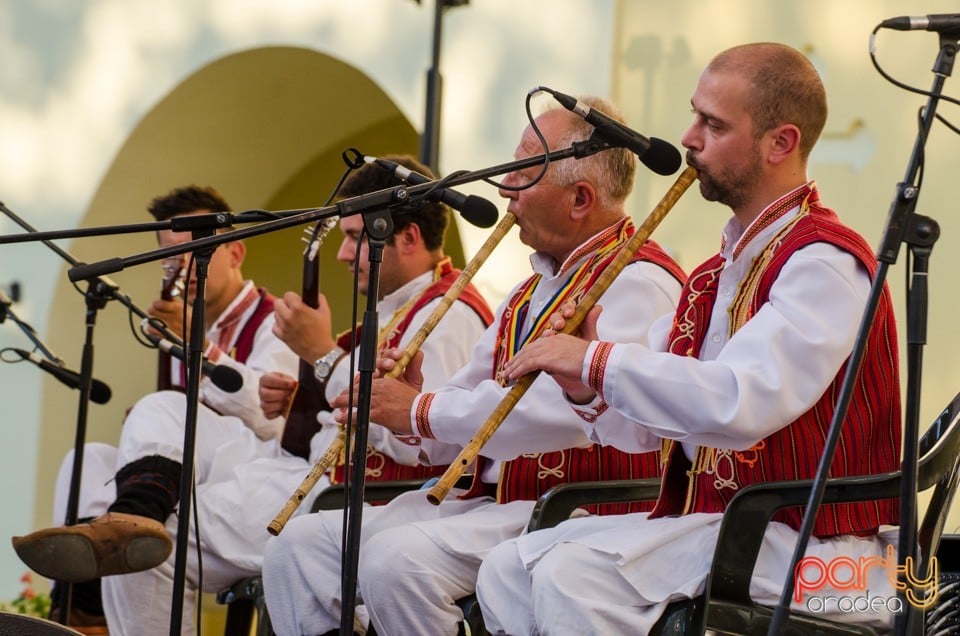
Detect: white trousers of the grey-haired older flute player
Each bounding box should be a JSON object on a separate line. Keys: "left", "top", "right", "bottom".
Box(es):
{"left": 263, "top": 490, "right": 534, "bottom": 636}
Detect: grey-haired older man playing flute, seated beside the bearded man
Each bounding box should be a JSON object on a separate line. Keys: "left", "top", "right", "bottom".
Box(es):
{"left": 263, "top": 98, "right": 684, "bottom": 634}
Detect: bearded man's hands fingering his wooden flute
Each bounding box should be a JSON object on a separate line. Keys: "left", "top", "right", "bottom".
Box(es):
{"left": 503, "top": 303, "right": 602, "bottom": 404}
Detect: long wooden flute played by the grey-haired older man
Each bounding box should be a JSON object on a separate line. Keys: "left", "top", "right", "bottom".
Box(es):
{"left": 267, "top": 212, "right": 517, "bottom": 536}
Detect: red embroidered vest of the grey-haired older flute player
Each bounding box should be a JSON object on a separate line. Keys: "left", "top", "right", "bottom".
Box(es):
{"left": 462, "top": 223, "right": 686, "bottom": 514}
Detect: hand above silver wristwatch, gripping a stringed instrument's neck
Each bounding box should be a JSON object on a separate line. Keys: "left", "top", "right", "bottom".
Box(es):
{"left": 273, "top": 292, "right": 337, "bottom": 364}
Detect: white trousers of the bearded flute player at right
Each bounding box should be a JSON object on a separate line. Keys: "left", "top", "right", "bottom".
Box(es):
{"left": 477, "top": 513, "right": 896, "bottom": 636}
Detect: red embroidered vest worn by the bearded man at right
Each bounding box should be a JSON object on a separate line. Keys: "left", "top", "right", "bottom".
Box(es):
{"left": 651, "top": 190, "right": 900, "bottom": 537}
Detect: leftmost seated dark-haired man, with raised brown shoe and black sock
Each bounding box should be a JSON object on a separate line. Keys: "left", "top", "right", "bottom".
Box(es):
{"left": 13, "top": 186, "right": 297, "bottom": 634}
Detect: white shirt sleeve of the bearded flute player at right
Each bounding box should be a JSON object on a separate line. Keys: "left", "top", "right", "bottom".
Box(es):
{"left": 584, "top": 243, "right": 870, "bottom": 450}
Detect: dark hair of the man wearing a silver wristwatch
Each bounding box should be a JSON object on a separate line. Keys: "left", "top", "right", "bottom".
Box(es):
{"left": 337, "top": 155, "right": 450, "bottom": 251}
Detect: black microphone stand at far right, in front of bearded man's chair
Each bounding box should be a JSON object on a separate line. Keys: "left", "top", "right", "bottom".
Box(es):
{"left": 767, "top": 32, "right": 958, "bottom": 636}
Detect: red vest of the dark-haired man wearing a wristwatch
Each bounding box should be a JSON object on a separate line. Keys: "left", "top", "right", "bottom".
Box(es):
{"left": 330, "top": 259, "right": 493, "bottom": 484}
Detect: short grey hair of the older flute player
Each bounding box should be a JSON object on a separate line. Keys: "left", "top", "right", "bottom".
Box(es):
{"left": 544, "top": 95, "right": 637, "bottom": 208}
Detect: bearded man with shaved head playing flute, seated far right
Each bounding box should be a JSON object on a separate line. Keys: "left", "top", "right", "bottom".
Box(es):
{"left": 477, "top": 43, "right": 900, "bottom": 634}
